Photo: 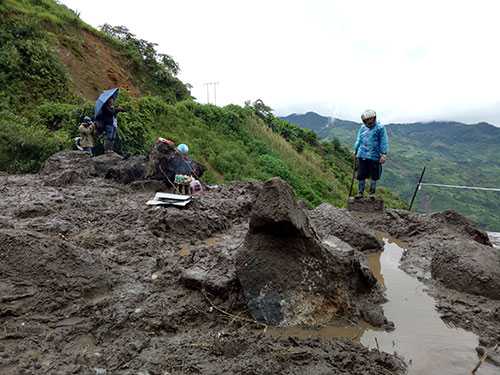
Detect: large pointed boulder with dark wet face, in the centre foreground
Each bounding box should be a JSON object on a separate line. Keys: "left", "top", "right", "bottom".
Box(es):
{"left": 236, "top": 178, "right": 376, "bottom": 326}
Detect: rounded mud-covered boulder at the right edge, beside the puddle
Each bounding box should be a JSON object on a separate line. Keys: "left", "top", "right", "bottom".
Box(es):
{"left": 431, "top": 238, "right": 500, "bottom": 299}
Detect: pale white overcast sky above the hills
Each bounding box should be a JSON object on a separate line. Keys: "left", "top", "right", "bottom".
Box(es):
{"left": 60, "top": 0, "right": 500, "bottom": 126}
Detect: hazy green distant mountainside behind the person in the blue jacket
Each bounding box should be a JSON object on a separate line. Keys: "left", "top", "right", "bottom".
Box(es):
{"left": 280, "top": 112, "right": 500, "bottom": 231}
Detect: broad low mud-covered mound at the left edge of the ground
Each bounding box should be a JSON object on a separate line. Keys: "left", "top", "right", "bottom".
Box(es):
{"left": 0, "top": 229, "right": 109, "bottom": 316}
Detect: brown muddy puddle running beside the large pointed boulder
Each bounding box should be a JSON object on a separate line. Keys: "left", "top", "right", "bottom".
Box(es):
{"left": 267, "top": 233, "right": 499, "bottom": 375}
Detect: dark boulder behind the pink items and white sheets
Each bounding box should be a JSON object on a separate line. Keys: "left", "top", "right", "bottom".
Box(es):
{"left": 143, "top": 142, "right": 205, "bottom": 186}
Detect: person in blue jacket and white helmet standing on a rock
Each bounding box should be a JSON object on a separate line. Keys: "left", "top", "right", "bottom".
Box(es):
{"left": 353, "top": 109, "right": 389, "bottom": 198}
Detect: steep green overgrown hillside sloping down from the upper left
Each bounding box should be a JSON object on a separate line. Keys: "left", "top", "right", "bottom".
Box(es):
{"left": 0, "top": 0, "right": 407, "bottom": 212}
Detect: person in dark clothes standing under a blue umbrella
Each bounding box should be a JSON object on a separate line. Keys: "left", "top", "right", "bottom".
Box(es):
{"left": 94, "top": 88, "right": 124, "bottom": 153}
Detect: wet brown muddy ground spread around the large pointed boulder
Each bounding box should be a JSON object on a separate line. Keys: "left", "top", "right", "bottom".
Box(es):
{"left": 0, "top": 153, "right": 500, "bottom": 375}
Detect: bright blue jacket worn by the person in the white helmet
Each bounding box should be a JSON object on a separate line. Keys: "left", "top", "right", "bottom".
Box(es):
{"left": 354, "top": 121, "right": 389, "bottom": 161}
